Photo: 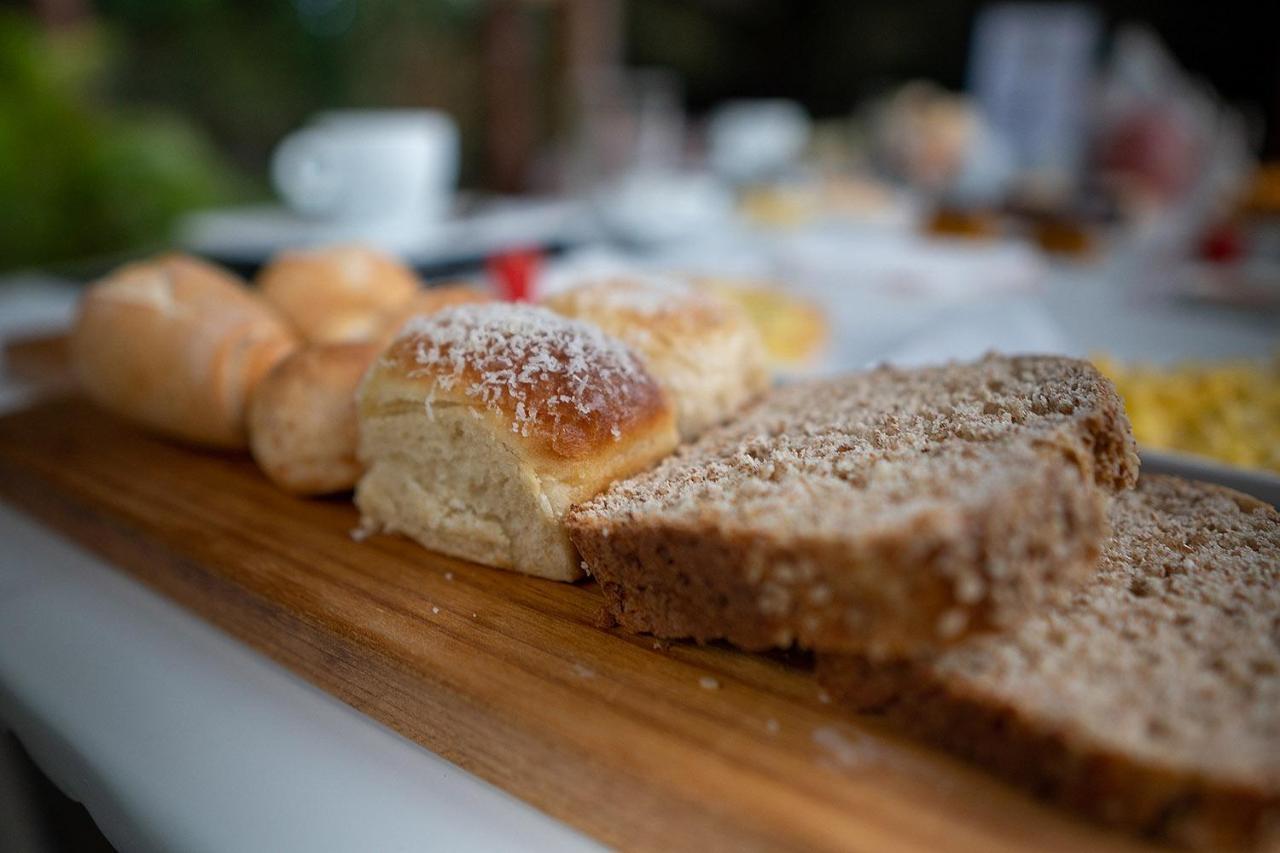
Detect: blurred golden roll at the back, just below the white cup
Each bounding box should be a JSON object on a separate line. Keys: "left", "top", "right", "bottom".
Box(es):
{"left": 257, "top": 246, "right": 419, "bottom": 343}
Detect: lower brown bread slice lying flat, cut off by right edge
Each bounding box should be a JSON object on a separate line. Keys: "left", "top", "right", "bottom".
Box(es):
{"left": 818, "top": 476, "right": 1280, "bottom": 849}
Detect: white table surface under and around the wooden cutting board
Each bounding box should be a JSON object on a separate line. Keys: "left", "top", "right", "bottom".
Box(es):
{"left": 0, "top": 251, "right": 1276, "bottom": 850}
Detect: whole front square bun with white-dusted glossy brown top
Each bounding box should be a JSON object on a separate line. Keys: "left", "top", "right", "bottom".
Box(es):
{"left": 356, "top": 302, "right": 677, "bottom": 580}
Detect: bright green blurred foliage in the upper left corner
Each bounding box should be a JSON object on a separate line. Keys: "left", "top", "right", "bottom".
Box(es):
{"left": 0, "top": 12, "right": 247, "bottom": 269}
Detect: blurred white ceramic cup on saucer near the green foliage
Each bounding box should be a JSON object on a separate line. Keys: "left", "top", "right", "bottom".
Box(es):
{"left": 271, "top": 110, "right": 458, "bottom": 220}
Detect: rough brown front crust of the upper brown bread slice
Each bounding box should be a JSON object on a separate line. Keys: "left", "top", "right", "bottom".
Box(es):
{"left": 571, "top": 438, "right": 1107, "bottom": 656}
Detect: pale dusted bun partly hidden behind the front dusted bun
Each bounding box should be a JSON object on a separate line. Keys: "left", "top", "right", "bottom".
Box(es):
{"left": 543, "top": 277, "right": 769, "bottom": 441}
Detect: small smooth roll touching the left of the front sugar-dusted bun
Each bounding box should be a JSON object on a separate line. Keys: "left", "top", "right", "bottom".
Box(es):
{"left": 248, "top": 343, "right": 381, "bottom": 494}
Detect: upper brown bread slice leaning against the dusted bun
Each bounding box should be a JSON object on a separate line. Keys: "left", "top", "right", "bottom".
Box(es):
{"left": 568, "top": 356, "right": 1138, "bottom": 656}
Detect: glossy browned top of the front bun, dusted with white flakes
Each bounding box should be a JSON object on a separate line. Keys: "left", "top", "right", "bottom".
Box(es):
{"left": 364, "top": 302, "right": 673, "bottom": 459}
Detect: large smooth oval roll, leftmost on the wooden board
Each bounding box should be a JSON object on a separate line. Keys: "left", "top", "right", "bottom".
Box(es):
{"left": 70, "top": 255, "right": 297, "bottom": 447}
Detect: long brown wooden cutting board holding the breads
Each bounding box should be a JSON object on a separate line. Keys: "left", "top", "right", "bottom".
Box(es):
{"left": 0, "top": 400, "right": 1152, "bottom": 852}
